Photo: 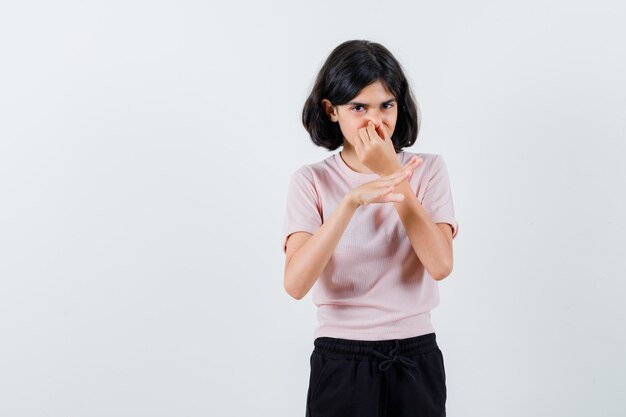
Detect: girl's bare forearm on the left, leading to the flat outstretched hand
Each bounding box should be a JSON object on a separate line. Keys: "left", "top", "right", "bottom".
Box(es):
{"left": 285, "top": 195, "right": 358, "bottom": 299}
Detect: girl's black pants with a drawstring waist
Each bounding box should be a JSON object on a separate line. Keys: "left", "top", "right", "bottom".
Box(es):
{"left": 306, "top": 333, "right": 446, "bottom": 417}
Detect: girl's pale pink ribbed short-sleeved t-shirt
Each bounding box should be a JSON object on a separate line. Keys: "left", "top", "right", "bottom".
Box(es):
{"left": 282, "top": 151, "right": 458, "bottom": 340}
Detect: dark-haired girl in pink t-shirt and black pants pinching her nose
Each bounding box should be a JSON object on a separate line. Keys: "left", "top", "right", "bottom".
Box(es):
{"left": 282, "top": 40, "right": 458, "bottom": 417}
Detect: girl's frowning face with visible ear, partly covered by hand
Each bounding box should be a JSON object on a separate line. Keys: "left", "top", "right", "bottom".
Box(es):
{"left": 322, "top": 81, "right": 398, "bottom": 148}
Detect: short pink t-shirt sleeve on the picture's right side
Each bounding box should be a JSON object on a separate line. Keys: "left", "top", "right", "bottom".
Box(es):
{"left": 422, "top": 155, "right": 459, "bottom": 239}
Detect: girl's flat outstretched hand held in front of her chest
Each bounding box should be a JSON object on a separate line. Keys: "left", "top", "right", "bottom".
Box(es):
{"left": 347, "top": 156, "right": 423, "bottom": 206}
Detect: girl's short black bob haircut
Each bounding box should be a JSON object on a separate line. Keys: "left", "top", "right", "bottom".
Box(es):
{"left": 302, "top": 40, "right": 421, "bottom": 153}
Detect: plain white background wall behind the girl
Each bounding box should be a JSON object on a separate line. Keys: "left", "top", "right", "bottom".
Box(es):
{"left": 0, "top": 0, "right": 626, "bottom": 417}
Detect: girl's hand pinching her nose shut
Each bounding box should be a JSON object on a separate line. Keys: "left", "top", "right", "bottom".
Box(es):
{"left": 354, "top": 120, "right": 400, "bottom": 176}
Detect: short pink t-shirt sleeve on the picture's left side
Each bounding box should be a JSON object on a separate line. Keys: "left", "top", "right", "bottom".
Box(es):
{"left": 282, "top": 165, "right": 322, "bottom": 253}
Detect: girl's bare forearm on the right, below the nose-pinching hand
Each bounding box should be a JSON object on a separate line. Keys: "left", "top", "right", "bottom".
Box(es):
{"left": 394, "top": 181, "right": 452, "bottom": 280}
